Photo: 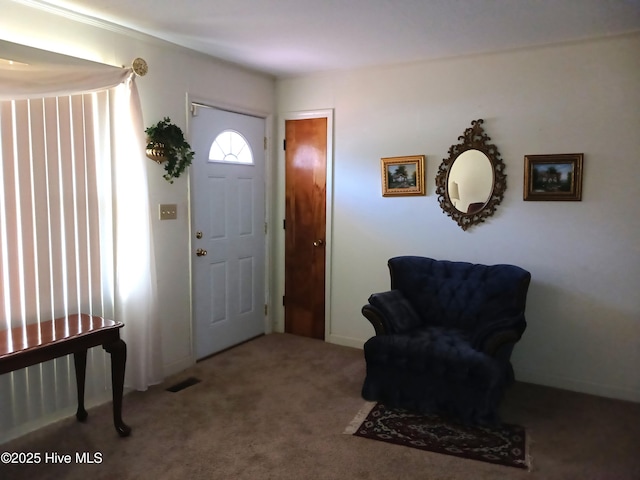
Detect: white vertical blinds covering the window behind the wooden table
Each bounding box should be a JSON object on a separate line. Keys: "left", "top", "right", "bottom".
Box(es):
{"left": 0, "top": 90, "right": 114, "bottom": 442}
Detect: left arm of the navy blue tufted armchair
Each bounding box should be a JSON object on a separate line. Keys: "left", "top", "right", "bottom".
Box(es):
{"left": 362, "top": 290, "right": 422, "bottom": 335}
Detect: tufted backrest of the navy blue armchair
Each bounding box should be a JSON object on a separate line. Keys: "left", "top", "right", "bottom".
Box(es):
{"left": 388, "top": 256, "right": 531, "bottom": 336}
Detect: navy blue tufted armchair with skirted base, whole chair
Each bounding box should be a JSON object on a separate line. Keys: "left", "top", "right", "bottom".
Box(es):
{"left": 362, "top": 256, "right": 531, "bottom": 424}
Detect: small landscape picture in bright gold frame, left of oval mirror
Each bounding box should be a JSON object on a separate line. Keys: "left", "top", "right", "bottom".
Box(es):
{"left": 380, "top": 155, "right": 426, "bottom": 197}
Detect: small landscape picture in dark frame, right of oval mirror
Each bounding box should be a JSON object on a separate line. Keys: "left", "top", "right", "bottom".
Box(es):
{"left": 524, "top": 153, "right": 584, "bottom": 201}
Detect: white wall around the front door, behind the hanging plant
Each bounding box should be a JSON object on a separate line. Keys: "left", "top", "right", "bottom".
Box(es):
{"left": 0, "top": 2, "right": 275, "bottom": 420}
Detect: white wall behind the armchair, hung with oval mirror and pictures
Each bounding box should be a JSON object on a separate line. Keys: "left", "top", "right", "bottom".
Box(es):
{"left": 277, "top": 35, "right": 640, "bottom": 401}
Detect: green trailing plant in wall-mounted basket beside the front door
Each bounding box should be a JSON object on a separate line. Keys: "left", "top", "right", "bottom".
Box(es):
{"left": 145, "top": 117, "right": 193, "bottom": 183}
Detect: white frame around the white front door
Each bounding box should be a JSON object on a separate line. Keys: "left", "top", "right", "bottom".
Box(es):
{"left": 186, "top": 93, "right": 276, "bottom": 364}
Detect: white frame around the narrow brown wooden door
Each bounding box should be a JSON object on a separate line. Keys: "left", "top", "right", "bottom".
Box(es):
{"left": 272, "top": 109, "right": 334, "bottom": 343}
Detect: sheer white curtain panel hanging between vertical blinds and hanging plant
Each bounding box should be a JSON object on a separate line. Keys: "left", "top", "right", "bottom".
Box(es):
{"left": 112, "top": 75, "right": 162, "bottom": 390}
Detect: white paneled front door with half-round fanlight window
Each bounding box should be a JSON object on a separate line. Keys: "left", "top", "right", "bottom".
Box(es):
{"left": 191, "top": 105, "right": 265, "bottom": 359}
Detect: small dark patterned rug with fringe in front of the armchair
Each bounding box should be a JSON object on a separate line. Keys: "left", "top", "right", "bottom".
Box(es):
{"left": 344, "top": 402, "right": 530, "bottom": 469}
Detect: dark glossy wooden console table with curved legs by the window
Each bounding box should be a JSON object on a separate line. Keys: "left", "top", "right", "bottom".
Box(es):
{"left": 0, "top": 314, "right": 131, "bottom": 437}
